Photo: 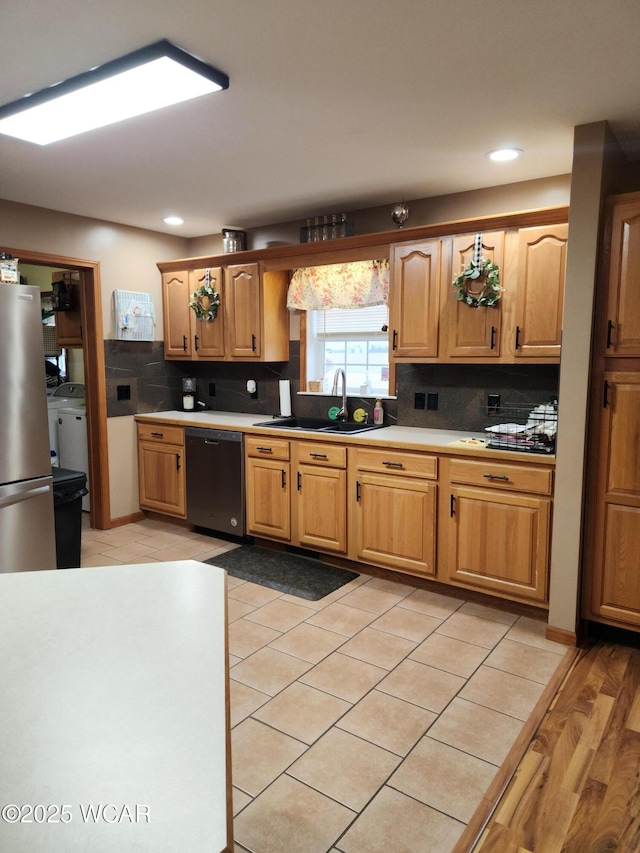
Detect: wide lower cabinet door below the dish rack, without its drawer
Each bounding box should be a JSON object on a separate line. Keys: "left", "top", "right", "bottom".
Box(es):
{"left": 448, "top": 488, "right": 551, "bottom": 601}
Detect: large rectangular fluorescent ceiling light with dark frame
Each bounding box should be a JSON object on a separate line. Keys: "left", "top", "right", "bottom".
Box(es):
{"left": 0, "top": 39, "right": 229, "bottom": 145}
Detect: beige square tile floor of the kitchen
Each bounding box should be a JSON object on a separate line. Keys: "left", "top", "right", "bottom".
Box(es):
{"left": 82, "top": 514, "right": 566, "bottom": 853}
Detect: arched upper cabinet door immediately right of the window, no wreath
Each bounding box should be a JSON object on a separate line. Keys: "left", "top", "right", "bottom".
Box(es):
{"left": 391, "top": 240, "right": 442, "bottom": 359}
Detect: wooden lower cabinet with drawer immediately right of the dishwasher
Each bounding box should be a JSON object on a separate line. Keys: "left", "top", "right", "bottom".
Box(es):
{"left": 245, "top": 437, "right": 291, "bottom": 542}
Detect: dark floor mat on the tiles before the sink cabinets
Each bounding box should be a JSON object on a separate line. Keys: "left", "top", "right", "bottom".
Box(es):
{"left": 206, "top": 545, "right": 358, "bottom": 601}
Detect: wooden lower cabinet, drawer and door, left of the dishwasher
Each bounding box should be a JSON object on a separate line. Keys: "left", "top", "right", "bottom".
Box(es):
{"left": 138, "top": 423, "right": 186, "bottom": 518}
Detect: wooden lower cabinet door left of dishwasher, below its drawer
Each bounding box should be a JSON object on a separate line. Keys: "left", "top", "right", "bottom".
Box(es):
{"left": 138, "top": 441, "right": 185, "bottom": 518}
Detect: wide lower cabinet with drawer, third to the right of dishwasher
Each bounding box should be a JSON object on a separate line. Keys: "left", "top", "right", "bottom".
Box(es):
{"left": 352, "top": 450, "right": 438, "bottom": 577}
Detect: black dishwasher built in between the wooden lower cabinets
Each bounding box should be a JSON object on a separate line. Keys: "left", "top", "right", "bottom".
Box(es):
{"left": 185, "top": 427, "right": 244, "bottom": 536}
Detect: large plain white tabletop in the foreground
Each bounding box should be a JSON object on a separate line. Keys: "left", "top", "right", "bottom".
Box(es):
{"left": 0, "top": 560, "right": 232, "bottom": 853}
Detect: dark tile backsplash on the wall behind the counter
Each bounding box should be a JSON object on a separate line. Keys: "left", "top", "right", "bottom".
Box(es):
{"left": 105, "top": 340, "right": 559, "bottom": 432}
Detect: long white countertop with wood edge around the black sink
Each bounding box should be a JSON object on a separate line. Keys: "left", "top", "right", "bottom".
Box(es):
{"left": 135, "top": 411, "right": 555, "bottom": 465}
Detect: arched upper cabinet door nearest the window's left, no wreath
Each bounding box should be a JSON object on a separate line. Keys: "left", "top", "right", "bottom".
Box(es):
{"left": 225, "top": 264, "right": 262, "bottom": 359}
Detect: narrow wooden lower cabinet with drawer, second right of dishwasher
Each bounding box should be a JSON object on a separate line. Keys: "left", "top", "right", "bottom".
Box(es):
{"left": 293, "top": 442, "right": 347, "bottom": 554}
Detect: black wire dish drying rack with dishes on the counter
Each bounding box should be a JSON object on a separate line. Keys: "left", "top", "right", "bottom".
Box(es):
{"left": 485, "top": 401, "right": 558, "bottom": 453}
